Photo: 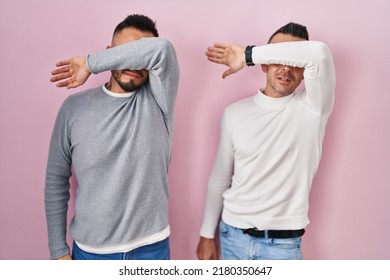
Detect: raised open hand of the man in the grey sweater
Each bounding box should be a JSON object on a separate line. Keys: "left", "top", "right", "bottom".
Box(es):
{"left": 50, "top": 56, "right": 91, "bottom": 89}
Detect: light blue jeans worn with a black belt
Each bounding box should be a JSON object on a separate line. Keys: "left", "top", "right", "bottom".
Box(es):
{"left": 219, "top": 221, "right": 303, "bottom": 260}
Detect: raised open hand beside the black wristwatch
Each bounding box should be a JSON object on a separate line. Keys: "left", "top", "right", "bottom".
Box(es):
{"left": 206, "top": 43, "right": 246, "bottom": 79}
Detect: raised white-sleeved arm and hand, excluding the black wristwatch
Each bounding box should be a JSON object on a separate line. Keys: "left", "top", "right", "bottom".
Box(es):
{"left": 206, "top": 41, "right": 336, "bottom": 114}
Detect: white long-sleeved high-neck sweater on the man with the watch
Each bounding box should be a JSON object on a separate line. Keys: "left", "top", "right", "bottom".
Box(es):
{"left": 201, "top": 41, "right": 335, "bottom": 238}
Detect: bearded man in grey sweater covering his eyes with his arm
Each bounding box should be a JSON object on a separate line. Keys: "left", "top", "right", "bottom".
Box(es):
{"left": 45, "top": 15, "right": 179, "bottom": 259}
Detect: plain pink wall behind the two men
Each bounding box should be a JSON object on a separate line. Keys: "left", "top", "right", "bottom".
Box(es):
{"left": 0, "top": 0, "right": 390, "bottom": 259}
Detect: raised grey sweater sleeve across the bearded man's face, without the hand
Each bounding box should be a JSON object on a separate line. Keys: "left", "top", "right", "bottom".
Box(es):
{"left": 87, "top": 37, "right": 180, "bottom": 119}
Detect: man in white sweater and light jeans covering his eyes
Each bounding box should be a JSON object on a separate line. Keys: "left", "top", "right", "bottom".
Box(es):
{"left": 197, "top": 23, "right": 335, "bottom": 259}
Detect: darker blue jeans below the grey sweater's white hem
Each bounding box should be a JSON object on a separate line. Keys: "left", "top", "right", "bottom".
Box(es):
{"left": 72, "top": 238, "right": 170, "bottom": 260}
